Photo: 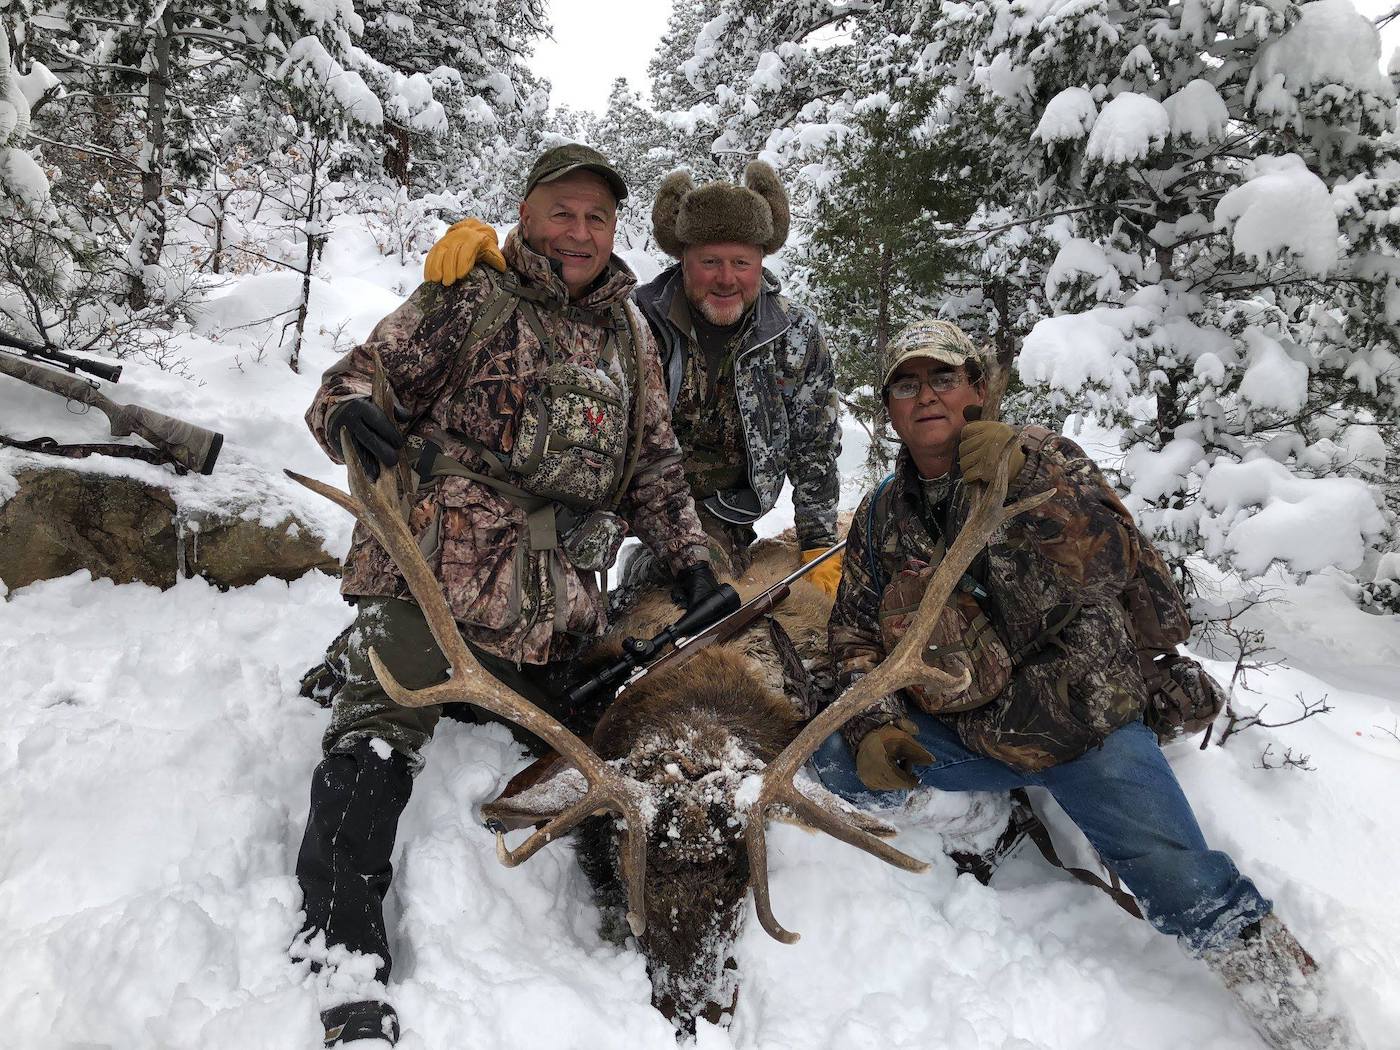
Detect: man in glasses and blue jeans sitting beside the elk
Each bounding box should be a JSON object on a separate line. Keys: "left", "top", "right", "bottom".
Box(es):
{"left": 815, "top": 321, "right": 1359, "bottom": 1050}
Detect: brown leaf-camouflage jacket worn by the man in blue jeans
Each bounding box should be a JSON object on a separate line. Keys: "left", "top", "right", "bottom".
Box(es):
{"left": 830, "top": 437, "right": 1147, "bottom": 770}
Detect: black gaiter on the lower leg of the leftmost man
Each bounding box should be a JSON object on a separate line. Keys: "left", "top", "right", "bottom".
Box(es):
{"left": 294, "top": 741, "right": 413, "bottom": 985}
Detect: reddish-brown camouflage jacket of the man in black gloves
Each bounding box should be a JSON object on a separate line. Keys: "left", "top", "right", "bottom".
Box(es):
{"left": 307, "top": 231, "right": 710, "bottom": 664}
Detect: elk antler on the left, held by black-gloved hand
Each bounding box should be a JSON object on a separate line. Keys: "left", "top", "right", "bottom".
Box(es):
{"left": 286, "top": 380, "right": 647, "bottom": 937}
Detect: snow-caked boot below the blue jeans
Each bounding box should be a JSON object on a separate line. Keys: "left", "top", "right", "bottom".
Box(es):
{"left": 1201, "top": 913, "right": 1365, "bottom": 1050}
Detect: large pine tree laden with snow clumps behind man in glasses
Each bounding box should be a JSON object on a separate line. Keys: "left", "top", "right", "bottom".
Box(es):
{"left": 932, "top": 0, "right": 1400, "bottom": 585}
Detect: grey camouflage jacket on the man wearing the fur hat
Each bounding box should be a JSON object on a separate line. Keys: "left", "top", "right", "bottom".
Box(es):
{"left": 633, "top": 265, "right": 841, "bottom": 550}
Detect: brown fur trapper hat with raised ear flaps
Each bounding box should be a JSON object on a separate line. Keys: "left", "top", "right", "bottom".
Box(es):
{"left": 651, "top": 161, "right": 788, "bottom": 259}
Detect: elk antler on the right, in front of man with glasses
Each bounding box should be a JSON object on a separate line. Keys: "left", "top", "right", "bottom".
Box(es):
{"left": 745, "top": 436, "right": 1054, "bottom": 944}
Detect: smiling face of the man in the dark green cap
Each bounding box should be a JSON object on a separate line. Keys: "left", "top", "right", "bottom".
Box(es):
{"left": 521, "top": 171, "right": 617, "bottom": 298}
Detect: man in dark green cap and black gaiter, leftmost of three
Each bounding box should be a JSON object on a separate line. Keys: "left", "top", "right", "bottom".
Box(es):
{"left": 294, "top": 146, "right": 714, "bottom": 1046}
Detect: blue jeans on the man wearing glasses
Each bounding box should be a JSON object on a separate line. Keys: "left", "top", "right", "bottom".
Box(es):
{"left": 812, "top": 711, "right": 1273, "bottom": 955}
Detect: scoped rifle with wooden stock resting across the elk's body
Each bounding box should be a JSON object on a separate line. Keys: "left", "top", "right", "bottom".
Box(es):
{"left": 564, "top": 539, "right": 846, "bottom": 710}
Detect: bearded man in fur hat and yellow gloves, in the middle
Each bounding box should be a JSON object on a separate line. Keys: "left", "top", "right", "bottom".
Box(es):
{"left": 424, "top": 161, "right": 841, "bottom": 594}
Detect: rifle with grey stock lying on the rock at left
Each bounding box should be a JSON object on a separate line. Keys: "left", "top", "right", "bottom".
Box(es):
{"left": 0, "top": 335, "right": 224, "bottom": 475}
